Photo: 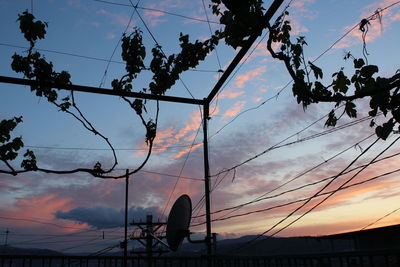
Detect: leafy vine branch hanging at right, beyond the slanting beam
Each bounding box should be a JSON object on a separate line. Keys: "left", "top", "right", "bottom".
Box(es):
{"left": 267, "top": 11, "right": 400, "bottom": 139}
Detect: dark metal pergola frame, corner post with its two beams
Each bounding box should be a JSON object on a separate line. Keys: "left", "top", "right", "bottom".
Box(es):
{"left": 0, "top": 0, "right": 284, "bottom": 256}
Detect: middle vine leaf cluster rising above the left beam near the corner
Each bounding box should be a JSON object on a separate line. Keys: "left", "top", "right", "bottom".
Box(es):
{"left": 111, "top": 28, "right": 222, "bottom": 115}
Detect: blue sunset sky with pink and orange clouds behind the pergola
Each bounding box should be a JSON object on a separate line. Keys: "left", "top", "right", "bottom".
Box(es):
{"left": 0, "top": 0, "right": 400, "bottom": 253}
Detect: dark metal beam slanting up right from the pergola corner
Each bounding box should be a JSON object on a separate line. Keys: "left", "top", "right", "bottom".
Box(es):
{"left": 206, "top": 0, "right": 284, "bottom": 103}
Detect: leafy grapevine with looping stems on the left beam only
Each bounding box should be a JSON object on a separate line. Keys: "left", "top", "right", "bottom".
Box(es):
{"left": 0, "top": 11, "right": 223, "bottom": 178}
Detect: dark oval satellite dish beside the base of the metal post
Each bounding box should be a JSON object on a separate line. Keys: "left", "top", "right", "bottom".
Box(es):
{"left": 167, "top": 195, "right": 192, "bottom": 251}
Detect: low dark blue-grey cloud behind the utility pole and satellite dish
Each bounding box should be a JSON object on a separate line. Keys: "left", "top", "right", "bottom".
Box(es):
{"left": 55, "top": 206, "right": 161, "bottom": 229}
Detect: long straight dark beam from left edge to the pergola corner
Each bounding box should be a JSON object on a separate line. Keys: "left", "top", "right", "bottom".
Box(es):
{"left": 0, "top": 76, "right": 204, "bottom": 105}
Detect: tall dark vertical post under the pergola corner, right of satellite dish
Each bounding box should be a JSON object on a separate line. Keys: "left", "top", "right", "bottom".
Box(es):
{"left": 203, "top": 98, "right": 212, "bottom": 257}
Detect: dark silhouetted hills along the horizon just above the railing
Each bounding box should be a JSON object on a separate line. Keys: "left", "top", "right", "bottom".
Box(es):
{"left": 0, "top": 225, "right": 400, "bottom": 256}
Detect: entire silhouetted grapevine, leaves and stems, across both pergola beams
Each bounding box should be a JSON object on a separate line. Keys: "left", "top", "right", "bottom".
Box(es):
{"left": 0, "top": 0, "right": 400, "bottom": 178}
